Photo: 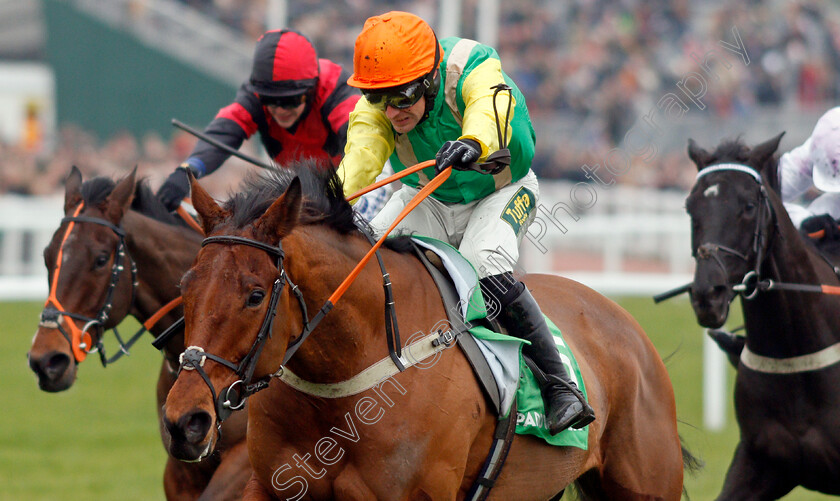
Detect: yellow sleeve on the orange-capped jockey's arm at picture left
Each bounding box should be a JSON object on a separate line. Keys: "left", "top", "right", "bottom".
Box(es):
{"left": 338, "top": 97, "right": 394, "bottom": 199}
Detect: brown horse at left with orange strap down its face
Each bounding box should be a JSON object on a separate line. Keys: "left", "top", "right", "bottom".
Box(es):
{"left": 29, "top": 167, "right": 250, "bottom": 500}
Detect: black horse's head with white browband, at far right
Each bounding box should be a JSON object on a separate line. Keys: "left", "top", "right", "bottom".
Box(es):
{"left": 686, "top": 133, "right": 784, "bottom": 328}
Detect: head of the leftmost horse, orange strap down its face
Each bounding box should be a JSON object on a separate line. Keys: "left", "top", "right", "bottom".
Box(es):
{"left": 28, "top": 167, "right": 136, "bottom": 392}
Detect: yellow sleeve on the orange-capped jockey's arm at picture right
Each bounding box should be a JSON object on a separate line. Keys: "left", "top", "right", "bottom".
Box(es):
{"left": 458, "top": 58, "right": 516, "bottom": 161}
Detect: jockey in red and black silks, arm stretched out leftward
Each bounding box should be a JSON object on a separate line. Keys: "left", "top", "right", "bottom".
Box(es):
{"left": 158, "top": 30, "right": 360, "bottom": 210}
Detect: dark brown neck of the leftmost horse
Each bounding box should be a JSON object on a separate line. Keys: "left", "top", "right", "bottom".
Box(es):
{"left": 122, "top": 211, "right": 202, "bottom": 344}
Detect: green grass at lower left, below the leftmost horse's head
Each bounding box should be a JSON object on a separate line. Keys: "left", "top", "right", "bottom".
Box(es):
{"left": 0, "top": 303, "right": 166, "bottom": 501}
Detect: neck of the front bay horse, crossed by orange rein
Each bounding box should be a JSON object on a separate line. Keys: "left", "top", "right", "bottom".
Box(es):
{"left": 278, "top": 226, "right": 446, "bottom": 382}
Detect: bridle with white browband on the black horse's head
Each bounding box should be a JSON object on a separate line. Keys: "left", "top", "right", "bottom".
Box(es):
{"left": 693, "top": 163, "right": 774, "bottom": 299}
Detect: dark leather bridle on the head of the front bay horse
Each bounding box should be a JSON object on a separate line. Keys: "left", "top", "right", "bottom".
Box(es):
{"left": 178, "top": 235, "right": 322, "bottom": 427}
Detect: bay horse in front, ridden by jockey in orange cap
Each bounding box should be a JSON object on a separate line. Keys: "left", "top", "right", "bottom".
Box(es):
{"left": 164, "top": 169, "right": 683, "bottom": 500}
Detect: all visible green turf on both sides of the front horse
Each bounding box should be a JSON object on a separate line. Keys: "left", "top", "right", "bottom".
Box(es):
{"left": 0, "top": 297, "right": 830, "bottom": 501}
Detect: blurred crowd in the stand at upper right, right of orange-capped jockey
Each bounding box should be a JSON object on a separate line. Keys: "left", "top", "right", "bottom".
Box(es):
{"left": 499, "top": 0, "right": 840, "bottom": 189}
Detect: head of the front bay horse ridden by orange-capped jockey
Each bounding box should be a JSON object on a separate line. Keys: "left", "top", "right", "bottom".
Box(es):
{"left": 163, "top": 169, "right": 303, "bottom": 461}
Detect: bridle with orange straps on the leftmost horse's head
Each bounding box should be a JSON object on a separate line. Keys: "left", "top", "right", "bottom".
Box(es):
{"left": 38, "top": 203, "right": 138, "bottom": 366}
